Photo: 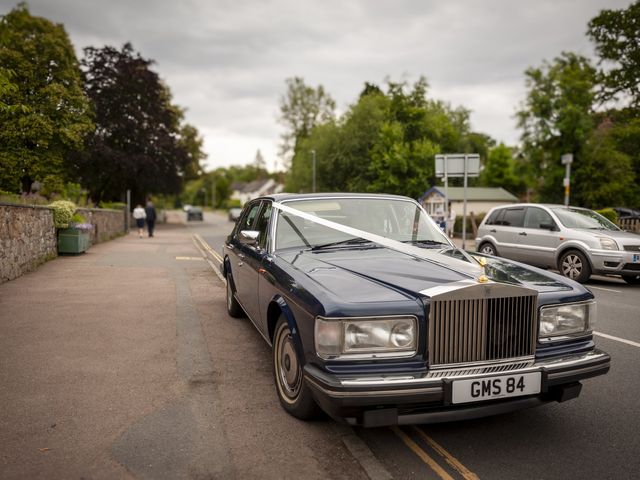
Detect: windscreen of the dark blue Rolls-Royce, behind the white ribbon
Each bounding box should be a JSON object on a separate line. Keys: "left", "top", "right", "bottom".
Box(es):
{"left": 276, "top": 198, "right": 449, "bottom": 249}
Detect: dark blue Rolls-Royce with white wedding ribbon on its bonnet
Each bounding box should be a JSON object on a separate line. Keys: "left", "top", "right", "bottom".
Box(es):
{"left": 221, "top": 193, "right": 610, "bottom": 426}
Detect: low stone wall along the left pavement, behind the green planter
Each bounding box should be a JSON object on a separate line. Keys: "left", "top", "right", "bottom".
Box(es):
{"left": 0, "top": 203, "right": 125, "bottom": 283}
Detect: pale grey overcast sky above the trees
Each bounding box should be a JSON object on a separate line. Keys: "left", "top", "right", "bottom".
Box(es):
{"left": 7, "top": 0, "right": 631, "bottom": 169}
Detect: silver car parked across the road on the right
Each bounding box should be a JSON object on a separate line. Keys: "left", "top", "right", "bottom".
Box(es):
{"left": 476, "top": 203, "right": 640, "bottom": 284}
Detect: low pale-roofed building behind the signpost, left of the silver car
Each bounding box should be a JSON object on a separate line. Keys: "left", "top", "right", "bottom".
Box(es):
{"left": 418, "top": 186, "right": 519, "bottom": 216}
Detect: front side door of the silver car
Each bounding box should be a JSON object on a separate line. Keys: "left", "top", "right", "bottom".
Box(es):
{"left": 518, "top": 207, "right": 560, "bottom": 267}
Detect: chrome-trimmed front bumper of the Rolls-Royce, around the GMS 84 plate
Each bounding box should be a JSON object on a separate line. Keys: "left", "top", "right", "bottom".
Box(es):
{"left": 304, "top": 350, "right": 611, "bottom": 427}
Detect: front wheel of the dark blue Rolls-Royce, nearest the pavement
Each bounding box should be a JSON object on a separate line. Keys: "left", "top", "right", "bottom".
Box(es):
{"left": 273, "top": 315, "right": 320, "bottom": 420}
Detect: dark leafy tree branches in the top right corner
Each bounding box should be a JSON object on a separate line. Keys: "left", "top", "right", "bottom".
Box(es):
{"left": 587, "top": 0, "right": 640, "bottom": 109}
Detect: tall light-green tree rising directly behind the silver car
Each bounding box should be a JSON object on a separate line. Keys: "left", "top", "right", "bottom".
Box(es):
{"left": 517, "top": 52, "right": 596, "bottom": 203}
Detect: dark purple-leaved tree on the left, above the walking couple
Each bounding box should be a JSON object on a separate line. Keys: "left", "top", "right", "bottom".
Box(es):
{"left": 76, "top": 43, "right": 195, "bottom": 202}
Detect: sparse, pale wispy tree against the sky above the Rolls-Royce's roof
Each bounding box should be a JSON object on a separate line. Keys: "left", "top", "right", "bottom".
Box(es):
{"left": 280, "top": 77, "right": 336, "bottom": 158}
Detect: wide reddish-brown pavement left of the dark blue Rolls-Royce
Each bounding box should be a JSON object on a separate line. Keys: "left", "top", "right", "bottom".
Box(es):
{"left": 0, "top": 220, "right": 365, "bottom": 480}
